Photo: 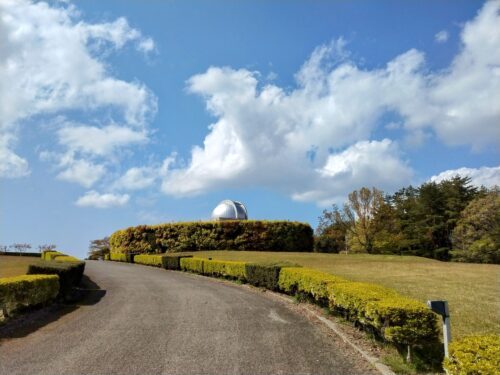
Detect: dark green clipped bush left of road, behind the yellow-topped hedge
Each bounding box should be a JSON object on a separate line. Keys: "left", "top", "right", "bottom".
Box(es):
{"left": 27, "top": 260, "right": 85, "bottom": 299}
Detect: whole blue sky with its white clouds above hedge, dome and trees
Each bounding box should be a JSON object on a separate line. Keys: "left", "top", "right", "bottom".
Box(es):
{"left": 0, "top": 0, "right": 500, "bottom": 257}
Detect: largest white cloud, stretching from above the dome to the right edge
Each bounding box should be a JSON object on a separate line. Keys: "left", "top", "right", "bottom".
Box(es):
{"left": 162, "top": 1, "right": 500, "bottom": 204}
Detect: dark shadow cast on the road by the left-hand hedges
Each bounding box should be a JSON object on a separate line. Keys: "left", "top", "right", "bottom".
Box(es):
{"left": 0, "top": 275, "right": 106, "bottom": 346}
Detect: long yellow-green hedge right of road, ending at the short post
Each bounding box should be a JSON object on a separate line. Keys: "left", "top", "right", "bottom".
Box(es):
{"left": 279, "top": 268, "right": 439, "bottom": 346}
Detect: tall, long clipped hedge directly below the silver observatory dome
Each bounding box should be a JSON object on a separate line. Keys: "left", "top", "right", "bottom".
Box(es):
{"left": 110, "top": 220, "right": 313, "bottom": 253}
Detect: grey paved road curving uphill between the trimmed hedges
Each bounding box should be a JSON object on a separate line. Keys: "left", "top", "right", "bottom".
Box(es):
{"left": 0, "top": 261, "right": 374, "bottom": 375}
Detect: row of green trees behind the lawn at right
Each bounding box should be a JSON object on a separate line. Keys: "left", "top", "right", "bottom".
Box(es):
{"left": 315, "top": 176, "right": 500, "bottom": 264}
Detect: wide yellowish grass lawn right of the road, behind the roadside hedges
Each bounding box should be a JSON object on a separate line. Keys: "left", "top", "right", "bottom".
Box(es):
{"left": 185, "top": 251, "right": 500, "bottom": 338}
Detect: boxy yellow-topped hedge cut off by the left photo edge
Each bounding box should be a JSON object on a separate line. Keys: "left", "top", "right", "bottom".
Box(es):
{"left": 0, "top": 275, "right": 59, "bottom": 321}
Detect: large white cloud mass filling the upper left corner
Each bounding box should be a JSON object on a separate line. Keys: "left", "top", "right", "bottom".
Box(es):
{"left": 0, "top": 0, "right": 156, "bottom": 177}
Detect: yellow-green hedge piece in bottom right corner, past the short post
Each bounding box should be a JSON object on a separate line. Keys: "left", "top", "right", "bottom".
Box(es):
{"left": 443, "top": 335, "right": 500, "bottom": 375}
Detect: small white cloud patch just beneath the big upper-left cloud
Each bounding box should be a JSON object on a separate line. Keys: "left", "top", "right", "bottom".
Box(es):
{"left": 57, "top": 125, "right": 147, "bottom": 156}
